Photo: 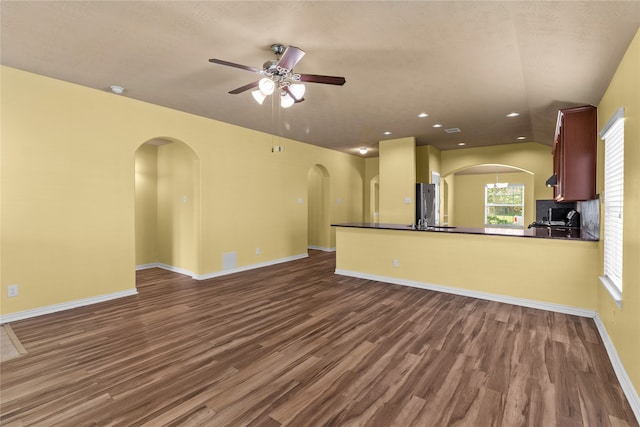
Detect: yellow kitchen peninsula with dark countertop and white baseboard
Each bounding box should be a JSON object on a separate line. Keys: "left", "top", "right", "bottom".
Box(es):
{"left": 334, "top": 223, "right": 598, "bottom": 316}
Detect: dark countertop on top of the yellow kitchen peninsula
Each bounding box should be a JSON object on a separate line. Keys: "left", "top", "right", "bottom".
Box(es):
{"left": 332, "top": 222, "right": 598, "bottom": 242}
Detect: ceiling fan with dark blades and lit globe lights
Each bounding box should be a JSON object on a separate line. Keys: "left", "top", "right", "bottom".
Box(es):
{"left": 209, "top": 43, "right": 347, "bottom": 108}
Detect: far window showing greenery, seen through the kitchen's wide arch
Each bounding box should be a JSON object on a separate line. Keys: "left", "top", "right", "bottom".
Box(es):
{"left": 484, "top": 183, "right": 524, "bottom": 227}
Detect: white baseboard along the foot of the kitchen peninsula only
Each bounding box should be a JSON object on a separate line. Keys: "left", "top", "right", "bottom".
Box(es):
{"left": 336, "top": 269, "right": 596, "bottom": 318}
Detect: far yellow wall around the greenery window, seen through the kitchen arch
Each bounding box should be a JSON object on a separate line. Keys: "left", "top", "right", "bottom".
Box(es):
{"left": 449, "top": 172, "right": 536, "bottom": 228}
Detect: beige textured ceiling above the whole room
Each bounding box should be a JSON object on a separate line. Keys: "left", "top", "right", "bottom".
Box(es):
{"left": 0, "top": 0, "right": 640, "bottom": 156}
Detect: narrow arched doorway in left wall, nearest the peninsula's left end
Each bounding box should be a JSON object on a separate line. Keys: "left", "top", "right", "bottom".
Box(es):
{"left": 307, "top": 165, "right": 332, "bottom": 251}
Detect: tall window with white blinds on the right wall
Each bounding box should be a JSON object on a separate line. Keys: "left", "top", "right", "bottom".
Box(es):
{"left": 600, "top": 108, "right": 624, "bottom": 305}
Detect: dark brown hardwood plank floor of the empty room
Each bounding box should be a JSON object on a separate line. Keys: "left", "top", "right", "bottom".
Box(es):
{"left": 0, "top": 251, "right": 638, "bottom": 427}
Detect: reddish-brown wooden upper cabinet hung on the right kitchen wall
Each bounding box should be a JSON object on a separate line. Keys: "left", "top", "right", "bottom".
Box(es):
{"left": 553, "top": 105, "right": 597, "bottom": 202}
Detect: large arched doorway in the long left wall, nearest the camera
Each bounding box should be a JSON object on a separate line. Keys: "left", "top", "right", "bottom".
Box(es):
{"left": 135, "top": 138, "right": 200, "bottom": 276}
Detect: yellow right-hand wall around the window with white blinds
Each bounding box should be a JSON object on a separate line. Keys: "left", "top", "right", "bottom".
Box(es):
{"left": 591, "top": 27, "right": 640, "bottom": 394}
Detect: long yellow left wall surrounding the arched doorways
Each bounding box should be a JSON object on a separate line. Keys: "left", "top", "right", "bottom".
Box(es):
{"left": 0, "top": 67, "right": 364, "bottom": 314}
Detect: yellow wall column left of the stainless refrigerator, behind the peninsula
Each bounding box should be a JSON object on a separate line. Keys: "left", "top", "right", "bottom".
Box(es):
{"left": 380, "top": 137, "right": 416, "bottom": 224}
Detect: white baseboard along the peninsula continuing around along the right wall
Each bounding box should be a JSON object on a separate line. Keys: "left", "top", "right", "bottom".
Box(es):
{"left": 335, "top": 269, "right": 640, "bottom": 423}
